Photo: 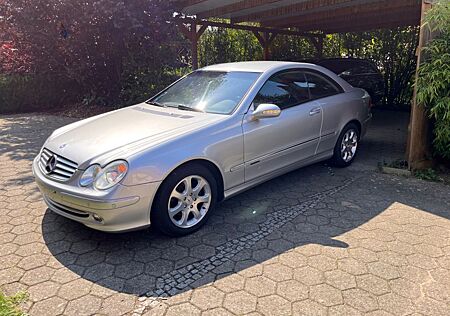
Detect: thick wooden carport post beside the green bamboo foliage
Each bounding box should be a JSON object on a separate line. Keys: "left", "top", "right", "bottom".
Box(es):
{"left": 406, "top": 0, "right": 432, "bottom": 169}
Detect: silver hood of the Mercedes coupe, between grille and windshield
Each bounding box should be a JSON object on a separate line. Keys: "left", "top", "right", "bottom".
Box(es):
{"left": 44, "top": 103, "right": 225, "bottom": 169}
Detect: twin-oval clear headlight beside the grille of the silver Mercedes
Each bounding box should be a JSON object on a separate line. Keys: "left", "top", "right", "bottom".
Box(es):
{"left": 80, "top": 160, "right": 128, "bottom": 190}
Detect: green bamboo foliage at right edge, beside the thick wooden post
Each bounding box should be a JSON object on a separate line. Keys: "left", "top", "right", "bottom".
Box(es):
{"left": 417, "top": 2, "right": 450, "bottom": 159}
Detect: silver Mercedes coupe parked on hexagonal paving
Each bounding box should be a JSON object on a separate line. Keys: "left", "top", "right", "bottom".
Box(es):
{"left": 33, "top": 61, "right": 371, "bottom": 235}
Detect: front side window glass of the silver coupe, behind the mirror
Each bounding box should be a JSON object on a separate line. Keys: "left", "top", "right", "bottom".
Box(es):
{"left": 253, "top": 71, "right": 310, "bottom": 110}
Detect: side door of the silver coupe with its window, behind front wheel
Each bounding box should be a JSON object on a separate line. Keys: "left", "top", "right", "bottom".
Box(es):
{"left": 242, "top": 70, "right": 322, "bottom": 182}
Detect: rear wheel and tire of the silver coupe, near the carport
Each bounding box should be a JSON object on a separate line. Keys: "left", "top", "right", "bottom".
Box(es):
{"left": 331, "top": 123, "right": 360, "bottom": 168}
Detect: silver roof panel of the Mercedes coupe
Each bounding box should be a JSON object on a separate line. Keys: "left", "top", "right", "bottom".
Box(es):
{"left": 201, "top": 61, "right": 313, "bottom": 72}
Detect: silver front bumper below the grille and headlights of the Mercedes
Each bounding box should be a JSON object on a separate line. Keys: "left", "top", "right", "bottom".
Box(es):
{"left": 33, "top": 157, "right": 161, "bottom": 232}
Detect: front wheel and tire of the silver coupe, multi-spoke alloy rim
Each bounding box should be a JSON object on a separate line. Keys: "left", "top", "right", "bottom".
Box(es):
{"left": 150, "top": 164, "right": 218, "bottom": 236}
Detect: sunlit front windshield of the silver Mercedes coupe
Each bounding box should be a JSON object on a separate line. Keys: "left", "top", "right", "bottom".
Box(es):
{"left": 147, "top": 70, "right": 260, "bottom": 114}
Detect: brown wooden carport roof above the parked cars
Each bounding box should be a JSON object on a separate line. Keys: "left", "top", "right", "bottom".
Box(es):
{"left": 176, "top": 0, "right": 422, "bottom": 34}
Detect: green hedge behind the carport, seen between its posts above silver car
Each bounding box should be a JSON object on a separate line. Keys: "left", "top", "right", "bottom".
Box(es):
{"left": 199, "top": 27, "right": 417, "bottom": 106}
